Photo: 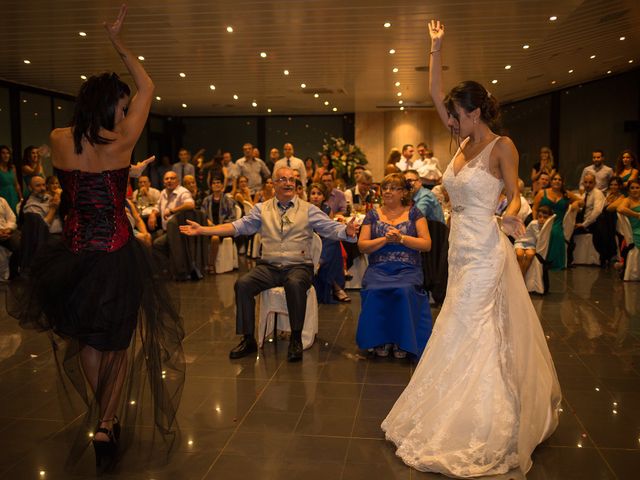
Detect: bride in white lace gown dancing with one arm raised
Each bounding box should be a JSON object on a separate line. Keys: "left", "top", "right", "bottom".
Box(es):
{"left": 382, "top": 21, "right": 561, "bottom": 477}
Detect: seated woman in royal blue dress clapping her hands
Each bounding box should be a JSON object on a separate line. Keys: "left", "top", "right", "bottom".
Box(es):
{"left": 356, "top": 173, "right": 431, "bottom": 358}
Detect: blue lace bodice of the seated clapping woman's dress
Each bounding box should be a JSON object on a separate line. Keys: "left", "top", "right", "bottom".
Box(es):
{"left": 363, "top": 207, "right": 422, "bottom": 265}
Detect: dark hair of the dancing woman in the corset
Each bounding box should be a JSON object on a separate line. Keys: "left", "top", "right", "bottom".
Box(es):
{"left": 70, "top": 73, "right": 131, "bottom": 154}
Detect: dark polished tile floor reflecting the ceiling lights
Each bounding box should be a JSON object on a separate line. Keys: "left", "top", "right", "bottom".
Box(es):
{"left": 0, "top": 267, "right": 640, "bottom": 480}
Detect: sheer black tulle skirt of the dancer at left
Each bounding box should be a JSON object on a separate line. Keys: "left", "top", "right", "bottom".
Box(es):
{"left": 7, "top": 237, "right": 185, "bottom": 467}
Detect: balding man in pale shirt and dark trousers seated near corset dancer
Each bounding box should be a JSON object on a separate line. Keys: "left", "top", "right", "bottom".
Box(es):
{"left": 148, "top": 170, "right": 195, "bottom": 280}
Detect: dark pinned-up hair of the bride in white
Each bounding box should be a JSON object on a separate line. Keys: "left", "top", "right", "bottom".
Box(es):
{"left": 444, "top": 80, "right": 500, "bottom": 129}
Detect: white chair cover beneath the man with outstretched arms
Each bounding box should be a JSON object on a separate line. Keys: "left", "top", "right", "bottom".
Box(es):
{"left": 258, "top": 233, "right": 322, "bottom": 350}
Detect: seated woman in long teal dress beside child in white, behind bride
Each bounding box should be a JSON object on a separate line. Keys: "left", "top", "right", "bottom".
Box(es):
{"left": 533, "top": 173, "right": 580, "bottom": 270}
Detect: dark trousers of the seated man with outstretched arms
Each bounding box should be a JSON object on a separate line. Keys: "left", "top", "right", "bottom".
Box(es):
{"left": 235, "top": 262, "right": 313, "bottom": 335}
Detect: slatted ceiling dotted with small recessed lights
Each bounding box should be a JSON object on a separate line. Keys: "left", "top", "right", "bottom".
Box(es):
{"left": 0, "top": 0, "right": 640, "bottom": 115}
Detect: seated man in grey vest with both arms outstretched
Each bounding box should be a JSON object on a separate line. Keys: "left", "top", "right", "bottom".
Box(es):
{"left": 180, "top": 167, "right": 356, "bottom": 362}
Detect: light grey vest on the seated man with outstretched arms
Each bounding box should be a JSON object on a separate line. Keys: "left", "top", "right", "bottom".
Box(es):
{"left": 260, "top": 198, "right": 313, "bottom": 266}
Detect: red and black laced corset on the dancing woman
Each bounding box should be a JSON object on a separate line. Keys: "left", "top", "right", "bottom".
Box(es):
{"left": 55, "top": 167, "right": 131, "bottom": 253}
